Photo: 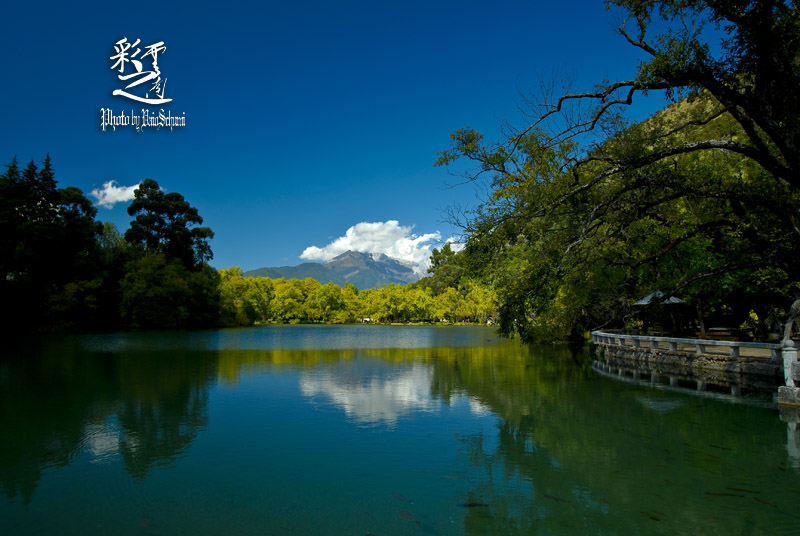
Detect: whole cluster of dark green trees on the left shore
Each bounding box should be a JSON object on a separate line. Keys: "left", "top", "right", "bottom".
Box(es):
{"left": 0, "top": 153, "right": 222, "bottom": 331}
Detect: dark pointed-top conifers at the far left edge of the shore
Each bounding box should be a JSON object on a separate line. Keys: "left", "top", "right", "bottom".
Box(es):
{"left": 0, "top": 155, "right": 102, "bottom": 329}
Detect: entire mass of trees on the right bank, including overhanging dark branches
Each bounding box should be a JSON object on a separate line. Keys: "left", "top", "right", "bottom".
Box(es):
{"left": 438, "top": 0, "right": 800, "bottom": 337}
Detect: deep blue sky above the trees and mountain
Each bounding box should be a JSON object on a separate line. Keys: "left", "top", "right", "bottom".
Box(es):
{"left": 0, "top": 0, "right": 660, "bottom": 270}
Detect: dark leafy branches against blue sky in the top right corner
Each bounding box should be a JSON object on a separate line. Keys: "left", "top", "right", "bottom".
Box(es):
{"left": 608, "top": 0, "right": 800, "bottom": 184}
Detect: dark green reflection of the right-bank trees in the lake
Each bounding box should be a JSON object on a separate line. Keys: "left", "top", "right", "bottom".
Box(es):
{"left": 432, "top": 342, "right": 794, "bottom": 534}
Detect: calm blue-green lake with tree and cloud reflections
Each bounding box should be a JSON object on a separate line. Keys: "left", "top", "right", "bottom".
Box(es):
{"left": 0, "top": 326, "right": 800, "bottom": 536}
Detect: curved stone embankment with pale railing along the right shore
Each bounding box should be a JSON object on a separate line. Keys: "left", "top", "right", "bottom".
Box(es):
{"left": 592, "top": 330, "right": 800, "bottom": 406}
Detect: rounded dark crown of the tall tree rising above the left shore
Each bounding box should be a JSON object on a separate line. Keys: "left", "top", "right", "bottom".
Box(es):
{"left": 125, "top": 179, "right": 214, "bottom": 269}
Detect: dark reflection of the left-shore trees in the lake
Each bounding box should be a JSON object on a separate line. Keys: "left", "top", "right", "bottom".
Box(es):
{"left": 0, "top": 341, "right": 216, "bottom": 504}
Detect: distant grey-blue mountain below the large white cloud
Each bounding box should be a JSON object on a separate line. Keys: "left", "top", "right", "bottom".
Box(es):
{"left": 244, "top": 251, "right": 420, "bottom": 289}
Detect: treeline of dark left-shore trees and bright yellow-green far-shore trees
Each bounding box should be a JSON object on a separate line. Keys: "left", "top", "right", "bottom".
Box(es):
{"left": 0, "top": 156, "right": 496, "bottom": 332}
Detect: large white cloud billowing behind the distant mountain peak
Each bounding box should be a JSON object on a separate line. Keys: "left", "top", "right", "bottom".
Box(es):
{"left": 300, "top": 220, "right": 442, "bottom": 274}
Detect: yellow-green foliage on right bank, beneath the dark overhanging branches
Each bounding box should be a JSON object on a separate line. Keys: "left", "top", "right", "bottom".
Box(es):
{"left": 440, "top": 104, "right": 800, "bottom": 340}
